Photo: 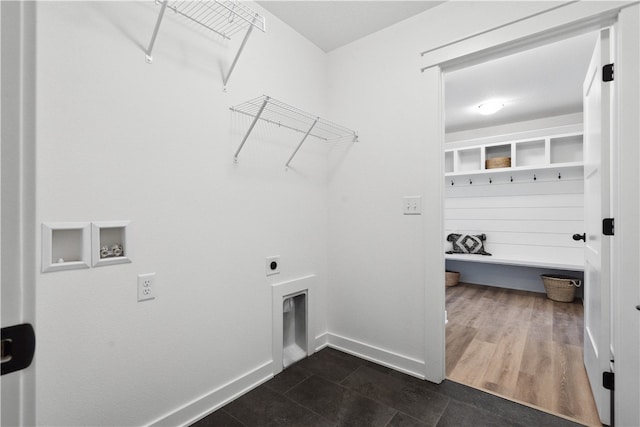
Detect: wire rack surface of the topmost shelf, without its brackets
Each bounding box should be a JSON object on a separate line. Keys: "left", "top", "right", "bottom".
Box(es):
{"left": 167, "top": 0, "right": 266, "bottom": 39}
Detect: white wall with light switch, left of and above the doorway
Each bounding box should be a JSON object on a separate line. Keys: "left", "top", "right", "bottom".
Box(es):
{"left": 328, "top": 2, "right": 576, "bottom": 381}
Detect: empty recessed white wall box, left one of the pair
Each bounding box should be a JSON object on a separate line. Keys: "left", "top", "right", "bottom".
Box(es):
{"left": 42, "top": 222, "right": 91, "bottom": 273}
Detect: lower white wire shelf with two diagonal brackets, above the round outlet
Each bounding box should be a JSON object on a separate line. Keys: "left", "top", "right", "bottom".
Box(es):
{"left": 230, "top": 95, "right": 358, "bottom": 167}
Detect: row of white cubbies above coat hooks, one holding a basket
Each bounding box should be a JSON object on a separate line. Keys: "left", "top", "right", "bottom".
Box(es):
{"left": 444, "top": 132, "right": 584, "bottom": 177}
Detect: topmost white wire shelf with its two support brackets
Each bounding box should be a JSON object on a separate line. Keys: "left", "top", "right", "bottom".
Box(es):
{"left": 146, "top": 0, "right": 266, "bottom": 87}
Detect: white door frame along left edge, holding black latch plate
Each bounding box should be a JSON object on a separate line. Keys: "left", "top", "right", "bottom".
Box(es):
{"left": 0, "top": 1, "right": 37, "bottom": 426}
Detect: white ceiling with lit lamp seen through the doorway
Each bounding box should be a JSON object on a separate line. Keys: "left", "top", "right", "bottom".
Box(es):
{"left": 445, "top": 34, "right": 596, "bottom": 132}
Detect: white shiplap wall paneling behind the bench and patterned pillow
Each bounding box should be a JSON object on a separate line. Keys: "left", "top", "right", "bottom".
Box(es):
{"left": 445, "top": 180, "right": 584, "bottom": 274}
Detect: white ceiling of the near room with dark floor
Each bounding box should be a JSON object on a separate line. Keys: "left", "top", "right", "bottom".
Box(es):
{"left": 258, "top": 0, "right": 444, "bottom": 52}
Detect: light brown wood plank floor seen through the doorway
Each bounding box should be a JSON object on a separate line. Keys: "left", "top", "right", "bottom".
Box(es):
{"left": 446, "top": 283, "right": 601, "bottom": 426}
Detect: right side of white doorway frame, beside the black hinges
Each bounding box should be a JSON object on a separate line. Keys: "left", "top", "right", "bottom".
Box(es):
{"left": 611, "top": 4, "right": 640, "bottom": 426}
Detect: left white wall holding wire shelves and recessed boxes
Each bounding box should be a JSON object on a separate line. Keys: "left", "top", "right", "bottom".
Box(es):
{"left": 36, "top": 1, "right": 332, "bottom": 426}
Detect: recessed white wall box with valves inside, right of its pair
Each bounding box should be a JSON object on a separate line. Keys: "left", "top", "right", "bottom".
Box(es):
{"left": 91, "top": 221, "right": 131, "bottom": 267}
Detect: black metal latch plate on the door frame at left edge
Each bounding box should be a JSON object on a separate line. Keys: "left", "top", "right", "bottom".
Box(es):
{"left": 0, "top": 323, "right": 36, "bottom": 375}
